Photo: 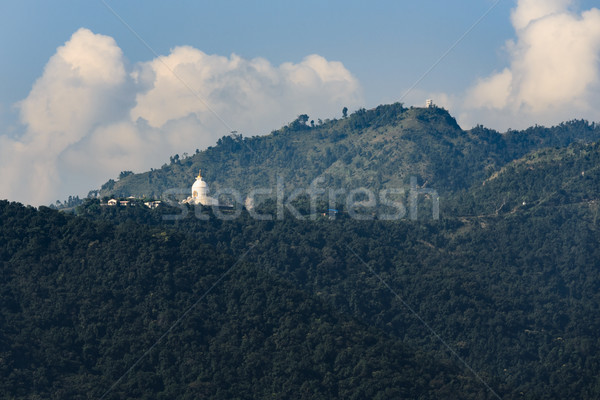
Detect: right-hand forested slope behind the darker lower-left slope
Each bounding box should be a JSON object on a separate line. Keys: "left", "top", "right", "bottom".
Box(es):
{"left": 91, "top": 155, "right": 600, "bottom": 399}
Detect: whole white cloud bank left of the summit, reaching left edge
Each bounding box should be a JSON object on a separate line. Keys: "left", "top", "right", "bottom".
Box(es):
{"left": 0, "top": 28, "right": 362, "bottom": 204}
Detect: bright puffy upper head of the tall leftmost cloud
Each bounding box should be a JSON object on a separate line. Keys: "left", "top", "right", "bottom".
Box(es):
{"left": 20, "top": 29, "right": 125, "bottom": 141}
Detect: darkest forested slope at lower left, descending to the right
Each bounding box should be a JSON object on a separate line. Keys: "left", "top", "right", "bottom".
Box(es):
{"left": 0, "top": 201, "right": 482, "bottom": 399}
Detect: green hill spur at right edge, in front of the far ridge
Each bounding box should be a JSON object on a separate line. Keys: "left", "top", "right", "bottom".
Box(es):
{"left": 445, "top": 142, "right": 600, "bottom": 219}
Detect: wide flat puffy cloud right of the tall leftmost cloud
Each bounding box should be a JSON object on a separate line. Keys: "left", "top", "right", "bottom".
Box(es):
{"left": 131, "top": 46, "right": 361, "bottom": 134}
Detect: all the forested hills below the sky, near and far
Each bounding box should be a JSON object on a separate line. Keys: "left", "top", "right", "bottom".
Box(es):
{"left": 0, "top": 104, "right": 600, "bottom": 399}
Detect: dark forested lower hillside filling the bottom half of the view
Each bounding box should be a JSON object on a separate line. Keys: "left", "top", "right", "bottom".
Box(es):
{"left": 0, "top": 152, "right": 600, "bottom": 399}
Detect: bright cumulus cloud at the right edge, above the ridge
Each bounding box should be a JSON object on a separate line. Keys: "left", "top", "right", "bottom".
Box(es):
{"left": 459, "top": 0, "right": 600, "bottom": 129}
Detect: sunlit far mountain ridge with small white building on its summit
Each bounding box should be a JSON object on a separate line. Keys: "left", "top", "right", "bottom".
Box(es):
{"left": 99, "top": 103, "right": 600, "bottom": 202}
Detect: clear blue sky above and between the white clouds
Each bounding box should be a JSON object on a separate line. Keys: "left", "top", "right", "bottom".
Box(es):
{"left": 0, "top": 0, "right": 514, "bottom": 114}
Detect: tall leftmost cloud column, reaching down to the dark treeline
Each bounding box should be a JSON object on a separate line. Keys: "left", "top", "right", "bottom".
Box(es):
{"left": 0, "top": 29, "right": 126, "bottom": 204}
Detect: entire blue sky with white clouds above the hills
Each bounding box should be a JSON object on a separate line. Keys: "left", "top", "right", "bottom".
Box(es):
{"left": 0, "top": 0, "right": 600, "bottom": 205}
